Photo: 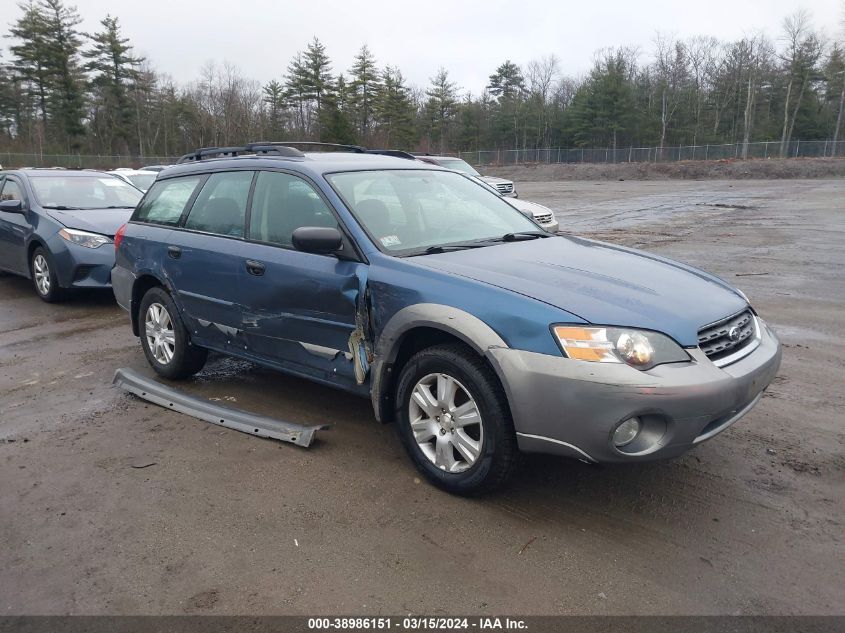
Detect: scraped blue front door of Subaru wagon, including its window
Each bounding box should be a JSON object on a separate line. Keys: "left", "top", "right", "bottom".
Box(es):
{"left": 234, "top": 171, "right": 367, "bottom": 389}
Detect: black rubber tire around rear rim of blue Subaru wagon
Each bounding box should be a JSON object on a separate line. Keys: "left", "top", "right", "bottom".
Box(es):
{"left": 138, "top": 287, "right": 208, "bottom": 380}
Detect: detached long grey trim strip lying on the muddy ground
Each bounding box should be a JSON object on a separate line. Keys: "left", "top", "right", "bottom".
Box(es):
{"left": 112, "top": 367, "right": 330, "bottom": 448}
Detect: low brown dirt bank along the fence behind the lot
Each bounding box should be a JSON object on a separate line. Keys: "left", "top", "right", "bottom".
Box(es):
{"left": 479, "top": 158, "right": 845, "bottom": 181}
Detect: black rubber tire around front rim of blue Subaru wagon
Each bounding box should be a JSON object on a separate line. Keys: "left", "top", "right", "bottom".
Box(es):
{"left": 396, "top": 344, "right": 518, "bottom": 496}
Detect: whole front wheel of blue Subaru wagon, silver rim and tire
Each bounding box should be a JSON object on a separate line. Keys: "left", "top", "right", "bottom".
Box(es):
{"left": 396, "top": 344, "right": 517, "bottom": 495}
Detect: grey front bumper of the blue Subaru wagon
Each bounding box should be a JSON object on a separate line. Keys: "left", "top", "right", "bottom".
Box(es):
{"left": 488, "top": 319, "right": 781, "bottom": 462}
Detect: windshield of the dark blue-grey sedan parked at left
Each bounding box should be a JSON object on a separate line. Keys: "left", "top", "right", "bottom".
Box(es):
{"left": 30, "top": 174, "right": 143, "bottom": 209}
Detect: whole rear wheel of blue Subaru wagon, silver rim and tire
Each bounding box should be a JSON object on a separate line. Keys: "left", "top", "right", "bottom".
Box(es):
{"left": 138, "top": 288, "right": 208, "bottom": 379}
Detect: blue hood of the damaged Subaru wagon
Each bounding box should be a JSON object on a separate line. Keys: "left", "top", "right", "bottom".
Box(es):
{"left": 414, "top": 236, "right": 747, "bottom": 347}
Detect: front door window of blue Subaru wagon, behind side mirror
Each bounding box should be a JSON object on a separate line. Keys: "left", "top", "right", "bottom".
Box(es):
{"left": 249, "top": 171, "right": 338, "bottom": 247}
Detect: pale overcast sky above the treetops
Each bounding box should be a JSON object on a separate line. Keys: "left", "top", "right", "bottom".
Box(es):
{"left": 0, "top": 0, "right": 845, "bottom": 93}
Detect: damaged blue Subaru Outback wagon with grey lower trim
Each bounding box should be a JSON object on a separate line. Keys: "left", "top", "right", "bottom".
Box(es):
{"left": 112, "top": 144, "right": 781, "bottom": 494}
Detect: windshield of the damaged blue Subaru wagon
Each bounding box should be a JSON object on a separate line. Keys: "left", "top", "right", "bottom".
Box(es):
{"left": 326, "top": 170, "right": 542, "bottom": 255}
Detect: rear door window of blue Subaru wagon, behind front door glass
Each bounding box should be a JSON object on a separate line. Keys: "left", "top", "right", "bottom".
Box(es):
{"left": 185, "top": 171, "right": 255, "bottom": 237}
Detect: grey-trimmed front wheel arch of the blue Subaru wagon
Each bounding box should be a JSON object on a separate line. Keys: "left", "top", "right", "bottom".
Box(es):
{"left": 370, "top": 304, "right": 508, "bottom": 423}
